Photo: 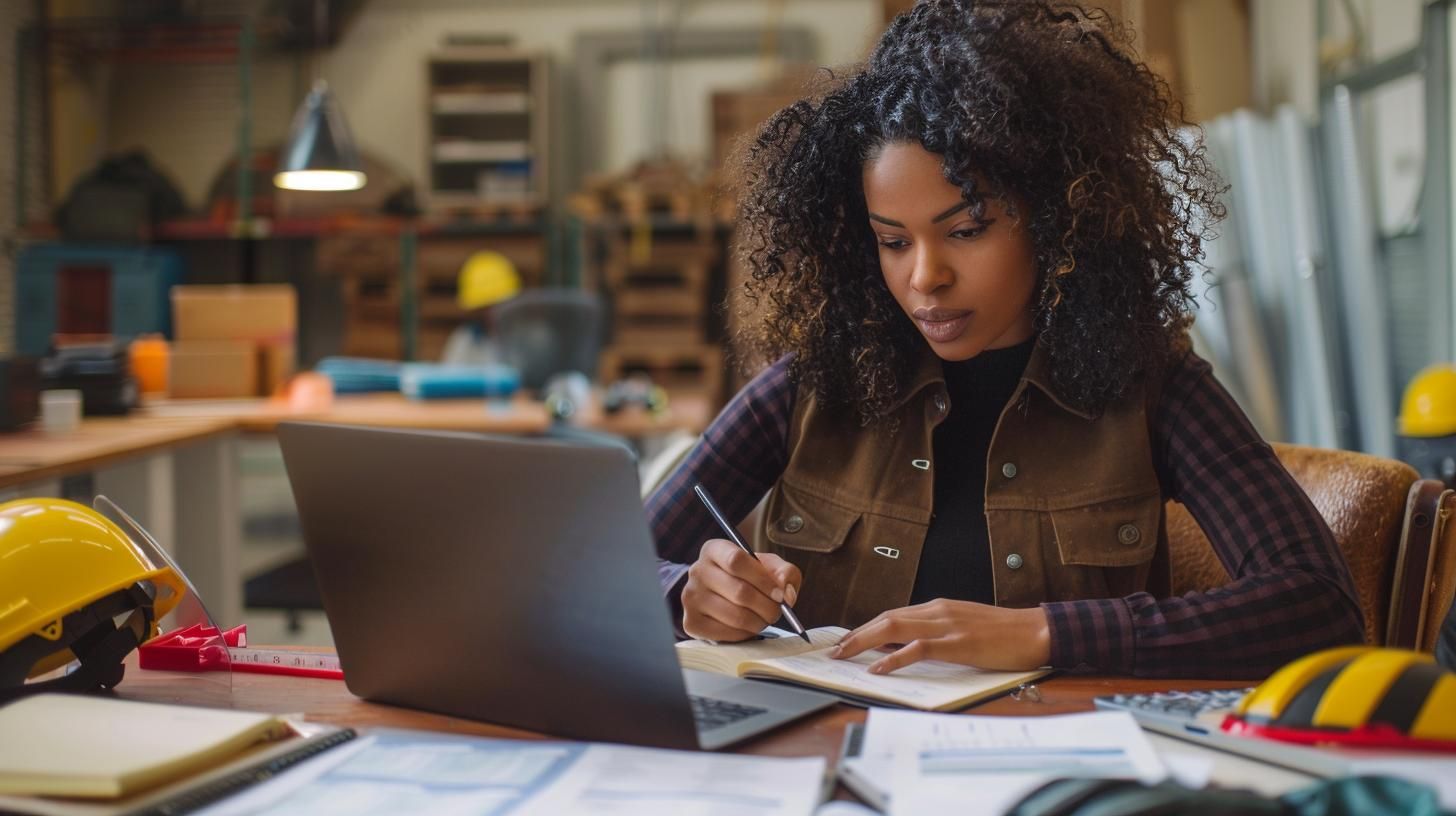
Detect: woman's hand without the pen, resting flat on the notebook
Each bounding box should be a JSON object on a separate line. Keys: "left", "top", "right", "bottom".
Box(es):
{"left": 830, "top": 597, "right": 1051, "bottom": 675}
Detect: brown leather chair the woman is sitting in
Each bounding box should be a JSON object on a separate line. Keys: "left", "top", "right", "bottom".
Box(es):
{"left": 1168, "top": 443, "right": 1428, "bottom": 646}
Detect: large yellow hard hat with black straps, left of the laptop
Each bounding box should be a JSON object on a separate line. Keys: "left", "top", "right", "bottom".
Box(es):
{"left": 0, "top": 498, "right": 186, "bottom": 702}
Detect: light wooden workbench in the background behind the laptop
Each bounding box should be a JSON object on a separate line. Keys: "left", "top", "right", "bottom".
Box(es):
{"left": 0, "top": 393, "right": 712, "bottom": 635}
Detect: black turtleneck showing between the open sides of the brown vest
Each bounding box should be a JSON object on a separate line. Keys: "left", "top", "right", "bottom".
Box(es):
{"left": 910, "top": 340, "right": 1035, "bottom": 603}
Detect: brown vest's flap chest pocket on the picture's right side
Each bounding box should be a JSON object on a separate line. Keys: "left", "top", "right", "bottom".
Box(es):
{"left": 1050, "top": 493, "right": 1162, "bottom": 567}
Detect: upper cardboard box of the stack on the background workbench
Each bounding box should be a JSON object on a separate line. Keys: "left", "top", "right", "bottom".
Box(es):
{"left": 172, "top": 284, "right": 298, "bottom": 344}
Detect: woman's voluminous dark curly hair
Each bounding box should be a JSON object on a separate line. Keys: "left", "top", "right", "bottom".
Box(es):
{"left": 734, "top": 0, "right": 1223, "bottom": 423}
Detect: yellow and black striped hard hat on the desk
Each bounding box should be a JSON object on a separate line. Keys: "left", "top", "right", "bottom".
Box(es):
{"left": 1223, "top": 646, "right": 1456, "bottom": 750}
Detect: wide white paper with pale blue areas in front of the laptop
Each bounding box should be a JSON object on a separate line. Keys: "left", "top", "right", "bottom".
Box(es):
{"left": 205, "top": 730, "right": 824, "bottom": 816}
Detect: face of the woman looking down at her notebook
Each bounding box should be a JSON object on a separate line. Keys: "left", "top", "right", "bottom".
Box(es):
{"left": 865, "top": 141, "right": 1037, "bottom": 360}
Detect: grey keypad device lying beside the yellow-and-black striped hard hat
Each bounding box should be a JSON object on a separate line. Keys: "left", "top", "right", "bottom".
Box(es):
{"left": 1093, "top": 688, "right": 1350, "bottom": 777}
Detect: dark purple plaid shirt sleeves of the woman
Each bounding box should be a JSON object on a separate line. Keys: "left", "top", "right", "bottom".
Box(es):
{"left": 646, "top": 354, "right": 1364, "bottom": 678}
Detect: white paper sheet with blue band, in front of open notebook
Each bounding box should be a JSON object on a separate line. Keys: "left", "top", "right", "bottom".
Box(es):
{"left": 863, "top": 708, "right": 1168, "bottom": 816}
